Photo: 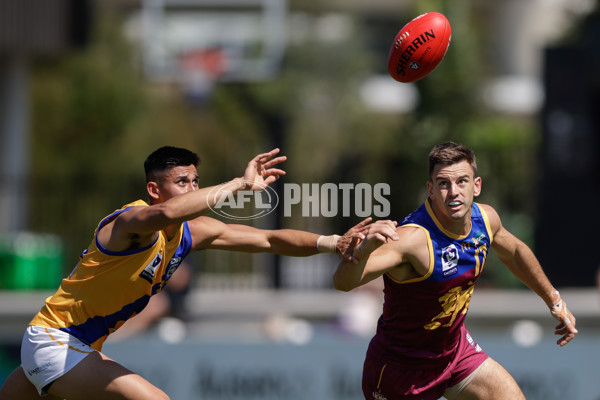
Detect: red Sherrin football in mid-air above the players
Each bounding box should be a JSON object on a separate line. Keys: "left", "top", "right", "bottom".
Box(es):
{"left": 388, "top": 12, "right": 452, "bottom": 83}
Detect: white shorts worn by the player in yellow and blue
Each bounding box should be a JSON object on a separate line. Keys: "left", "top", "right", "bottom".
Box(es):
{"left": 21, "top": 326, "right": 95, "bottom": 396}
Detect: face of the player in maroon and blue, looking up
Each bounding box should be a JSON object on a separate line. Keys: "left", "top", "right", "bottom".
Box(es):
{"left": 427, "top": 160, "right": 481, "bottom": 224}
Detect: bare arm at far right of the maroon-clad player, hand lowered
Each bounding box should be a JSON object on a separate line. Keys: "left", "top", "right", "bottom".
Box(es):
{"left": 483, "top": 205, "right": 577, "bottom": 346}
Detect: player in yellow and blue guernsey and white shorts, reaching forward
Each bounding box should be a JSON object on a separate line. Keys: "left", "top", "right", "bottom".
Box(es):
{"left": 0, "top": 146, "right": 368, "bottom": 400}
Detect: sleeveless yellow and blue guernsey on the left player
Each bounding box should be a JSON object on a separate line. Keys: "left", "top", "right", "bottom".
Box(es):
{"left": 29, "top": 200, "right": 192, "bottom": 350}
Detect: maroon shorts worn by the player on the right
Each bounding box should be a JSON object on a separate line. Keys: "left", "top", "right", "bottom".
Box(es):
{"left": 362, "top": 326, "right": 488, "bottom": 400}
